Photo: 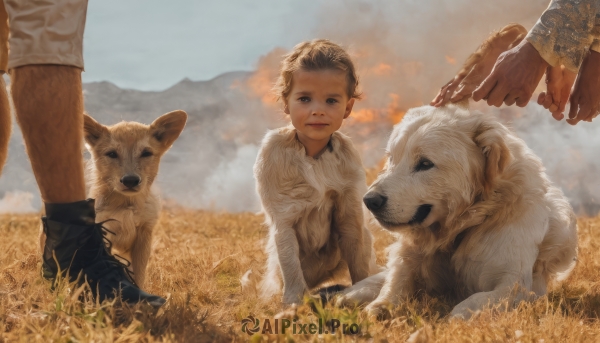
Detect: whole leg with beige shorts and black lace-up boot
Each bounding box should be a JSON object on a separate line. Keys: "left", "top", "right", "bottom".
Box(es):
{"left": 4, "top": 0, "right": 165, "bottom": 306}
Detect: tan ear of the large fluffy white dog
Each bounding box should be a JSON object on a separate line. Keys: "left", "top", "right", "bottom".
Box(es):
{"left": 473, "top": 123, "right": 511, "bottom": 192}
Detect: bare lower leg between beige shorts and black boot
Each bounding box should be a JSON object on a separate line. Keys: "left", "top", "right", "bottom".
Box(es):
{"left": 11, "top": 65, "right": 85, "bottom": 203}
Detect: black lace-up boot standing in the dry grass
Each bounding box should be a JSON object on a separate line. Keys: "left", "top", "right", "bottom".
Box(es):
{"left": 42, "top": 199, "right": 165, "bottom": 307}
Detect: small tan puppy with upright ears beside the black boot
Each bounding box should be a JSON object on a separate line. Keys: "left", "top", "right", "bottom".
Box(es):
{"left": 84, "top": 110, "right": 187, "bottom": 288}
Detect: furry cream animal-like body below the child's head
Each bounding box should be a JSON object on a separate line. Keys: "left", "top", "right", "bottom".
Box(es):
{"left": 254, "top": 126, "right": 377, "bottom": 304}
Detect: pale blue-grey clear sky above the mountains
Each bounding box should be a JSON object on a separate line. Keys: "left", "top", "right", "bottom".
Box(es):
{"left": 83, "top": 0, "right": 324, "bottom": 90}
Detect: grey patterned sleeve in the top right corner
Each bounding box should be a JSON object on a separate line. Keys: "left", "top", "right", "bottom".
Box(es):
{"left": 526, "top": 0, "right": 600, "bottom": 73}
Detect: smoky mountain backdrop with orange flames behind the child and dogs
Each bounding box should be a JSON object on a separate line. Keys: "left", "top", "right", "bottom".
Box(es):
{"left": 0, "top": 0, "right": 600, "bottom": 215}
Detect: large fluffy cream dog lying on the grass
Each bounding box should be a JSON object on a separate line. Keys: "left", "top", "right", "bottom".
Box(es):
{"left": 341, "top": 106, "right": 577, "bottom": 318}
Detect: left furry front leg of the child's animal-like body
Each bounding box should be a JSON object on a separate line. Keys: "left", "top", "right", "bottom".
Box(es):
{"left": 273, "top": 226, "right": 308, "bottom": 304}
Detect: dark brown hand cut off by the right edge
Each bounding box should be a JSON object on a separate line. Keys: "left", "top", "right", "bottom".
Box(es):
{"left": 567, "top": 50, "right": 600, "bottom": 125}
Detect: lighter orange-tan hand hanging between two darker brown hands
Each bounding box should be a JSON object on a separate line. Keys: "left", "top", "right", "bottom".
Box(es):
{"left": 538, "top": 65, "right": 577, "bottom": 120}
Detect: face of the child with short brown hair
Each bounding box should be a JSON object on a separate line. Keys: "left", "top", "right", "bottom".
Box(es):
{"left": 285, "top": 69, "right": 354, "bottom": 147}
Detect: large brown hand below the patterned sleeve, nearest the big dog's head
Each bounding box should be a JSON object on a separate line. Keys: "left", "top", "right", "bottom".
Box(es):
{"left": 473, "top": 40, "right": 548, "bottom": 107}
